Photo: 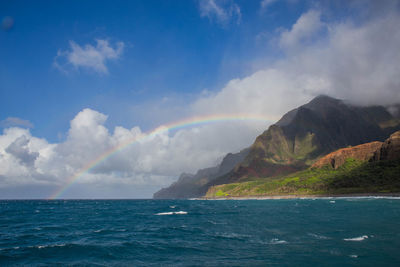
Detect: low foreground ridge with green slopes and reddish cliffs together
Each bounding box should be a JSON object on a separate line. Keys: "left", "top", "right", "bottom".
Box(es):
{"left": 206, "top": 131, "right": 400, "bottom": 198}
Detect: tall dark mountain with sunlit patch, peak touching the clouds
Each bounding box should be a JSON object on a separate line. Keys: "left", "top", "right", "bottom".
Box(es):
{"left": 210, "top": 95, "right": 400, "bottom": 186}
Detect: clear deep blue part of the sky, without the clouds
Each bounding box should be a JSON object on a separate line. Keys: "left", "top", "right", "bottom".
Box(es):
{"left": 0, "top": 1, "right": 310, "bottom": 141}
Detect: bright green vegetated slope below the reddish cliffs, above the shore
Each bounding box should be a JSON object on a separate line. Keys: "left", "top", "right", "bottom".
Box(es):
{"left": 206, "top": 158, "right": 400, "bottom": 197}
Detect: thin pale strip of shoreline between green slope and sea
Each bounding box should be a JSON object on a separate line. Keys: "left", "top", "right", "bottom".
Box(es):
{"left": 202, "top": 193, "right": 400, "bottom": 200}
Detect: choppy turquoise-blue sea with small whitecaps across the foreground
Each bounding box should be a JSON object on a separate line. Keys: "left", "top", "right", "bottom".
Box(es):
{"left": 0, "top": 198, "right": 400, "bottom": 266}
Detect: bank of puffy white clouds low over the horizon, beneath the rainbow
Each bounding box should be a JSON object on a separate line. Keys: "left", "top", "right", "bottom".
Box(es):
{"left": 0, "top": 109, "right": 268, "bottom": 197}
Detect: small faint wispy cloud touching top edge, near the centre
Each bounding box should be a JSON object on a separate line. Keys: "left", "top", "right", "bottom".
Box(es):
{"left": 199, "top": 0, "right": 242, "bottom": 25}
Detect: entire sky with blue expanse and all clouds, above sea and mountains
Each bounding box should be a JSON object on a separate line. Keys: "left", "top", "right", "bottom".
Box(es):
{"left": 0, "top": 0, "right": 400, "bottom": 198}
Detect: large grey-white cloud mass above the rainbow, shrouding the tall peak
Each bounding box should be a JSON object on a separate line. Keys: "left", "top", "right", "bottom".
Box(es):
{"left": 193, "top": 4, "right": 400, "bottom": 120}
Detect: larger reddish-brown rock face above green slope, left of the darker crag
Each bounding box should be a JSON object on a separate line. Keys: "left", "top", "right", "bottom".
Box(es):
{"left": 311, "top": 142, "right": 382, "bottom": 169}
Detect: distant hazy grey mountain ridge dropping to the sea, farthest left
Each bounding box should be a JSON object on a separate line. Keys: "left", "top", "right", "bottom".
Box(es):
{"left": 153, "top": 149, "right": 249, "bottom": 199}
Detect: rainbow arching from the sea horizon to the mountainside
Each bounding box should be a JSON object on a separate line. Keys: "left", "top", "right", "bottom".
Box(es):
{"left": 48, "top": 114, "right": 277, "bottom": 199}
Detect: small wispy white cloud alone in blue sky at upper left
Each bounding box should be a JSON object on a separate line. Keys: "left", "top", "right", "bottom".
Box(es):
{"left": 54, "top": 39, "right": 125, "bottom": 74}
